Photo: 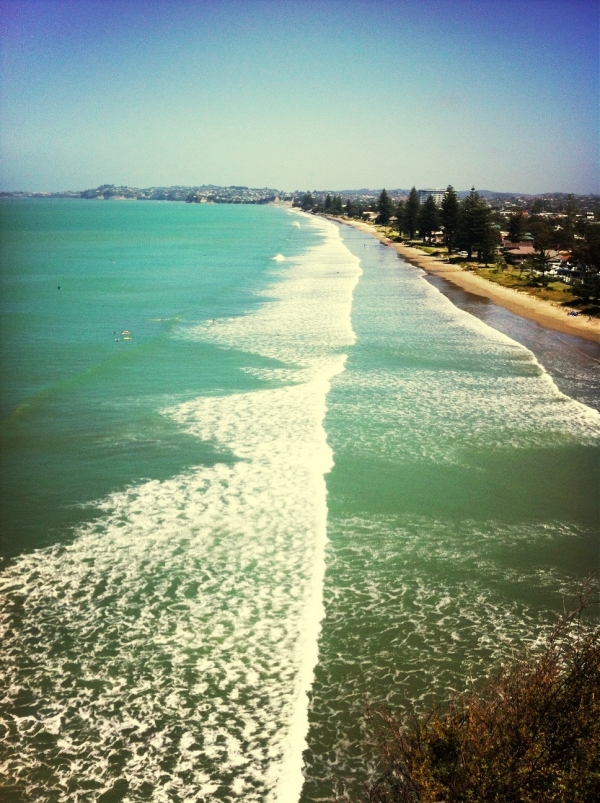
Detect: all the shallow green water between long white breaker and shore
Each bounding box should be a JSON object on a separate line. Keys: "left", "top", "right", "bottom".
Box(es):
{"left": 301, "top": 229, "right": 600, "bottom": 802}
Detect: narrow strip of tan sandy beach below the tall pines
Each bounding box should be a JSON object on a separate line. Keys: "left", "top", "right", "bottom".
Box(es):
{"left": 332, "top": 218, "right": 600, "bottom": 343}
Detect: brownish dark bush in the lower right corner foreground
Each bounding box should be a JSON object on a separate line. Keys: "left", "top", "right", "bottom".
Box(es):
{"left": 366, "top": 588, "right": 600, "bottom": 803}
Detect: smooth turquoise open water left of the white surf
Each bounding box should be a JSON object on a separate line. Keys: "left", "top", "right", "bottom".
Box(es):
{"left": 1, "top": 201, "right": 303, "bottom": 555}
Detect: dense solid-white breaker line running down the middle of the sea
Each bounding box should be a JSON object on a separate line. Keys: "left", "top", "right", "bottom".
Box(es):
{"left": 185, "top": 213, "right": 362, "bottom": 803}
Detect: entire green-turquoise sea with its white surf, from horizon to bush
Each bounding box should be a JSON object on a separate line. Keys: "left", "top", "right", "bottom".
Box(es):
{"left": 0, "top": 199, "right": 600, "bottom": 803}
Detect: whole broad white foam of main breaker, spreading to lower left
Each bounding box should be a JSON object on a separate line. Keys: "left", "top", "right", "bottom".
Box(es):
{"left": 0, "top": 215, "right": 359, "bottom": 803}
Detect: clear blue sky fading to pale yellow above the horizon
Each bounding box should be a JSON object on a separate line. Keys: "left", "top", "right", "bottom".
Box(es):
{"left": 0, "top": 0, "right": 600, "bottom": 193}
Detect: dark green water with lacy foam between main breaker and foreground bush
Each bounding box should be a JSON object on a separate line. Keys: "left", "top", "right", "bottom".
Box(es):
{"left": 302, "top": 516, "right": 590, "bottom": 801}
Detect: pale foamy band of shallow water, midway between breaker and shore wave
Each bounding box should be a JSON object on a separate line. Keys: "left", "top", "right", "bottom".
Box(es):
{"left": 332, "top": 367, "right": 600, "bottom": 462}
